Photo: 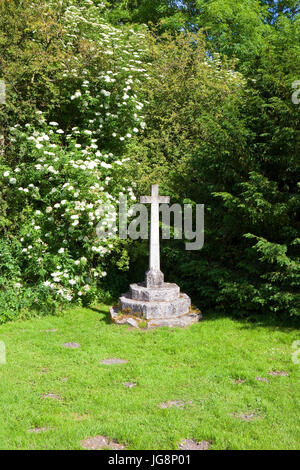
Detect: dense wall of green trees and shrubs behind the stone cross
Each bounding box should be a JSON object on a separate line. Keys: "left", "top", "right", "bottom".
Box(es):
{"left": 0, "top": 0, "right": 300, "bottom": 321}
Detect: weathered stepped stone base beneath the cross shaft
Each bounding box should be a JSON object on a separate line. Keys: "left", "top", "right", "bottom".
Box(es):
{"left": 110, "top": 283, "right": 201, "bottom": 328}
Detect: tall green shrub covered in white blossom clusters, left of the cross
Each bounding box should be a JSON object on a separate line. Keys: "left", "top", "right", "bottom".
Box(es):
{"left": 0, "top": 1, "right": 147, "bottom": 318}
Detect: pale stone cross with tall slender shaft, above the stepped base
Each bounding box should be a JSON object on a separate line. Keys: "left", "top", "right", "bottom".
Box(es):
{"left": 141, "top": 184, "right": 170, "bottom": 287}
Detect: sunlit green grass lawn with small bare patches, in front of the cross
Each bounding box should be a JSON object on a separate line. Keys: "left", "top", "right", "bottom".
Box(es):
{"left": 0, "top": 306, "right": 300, "bottom": 450}
